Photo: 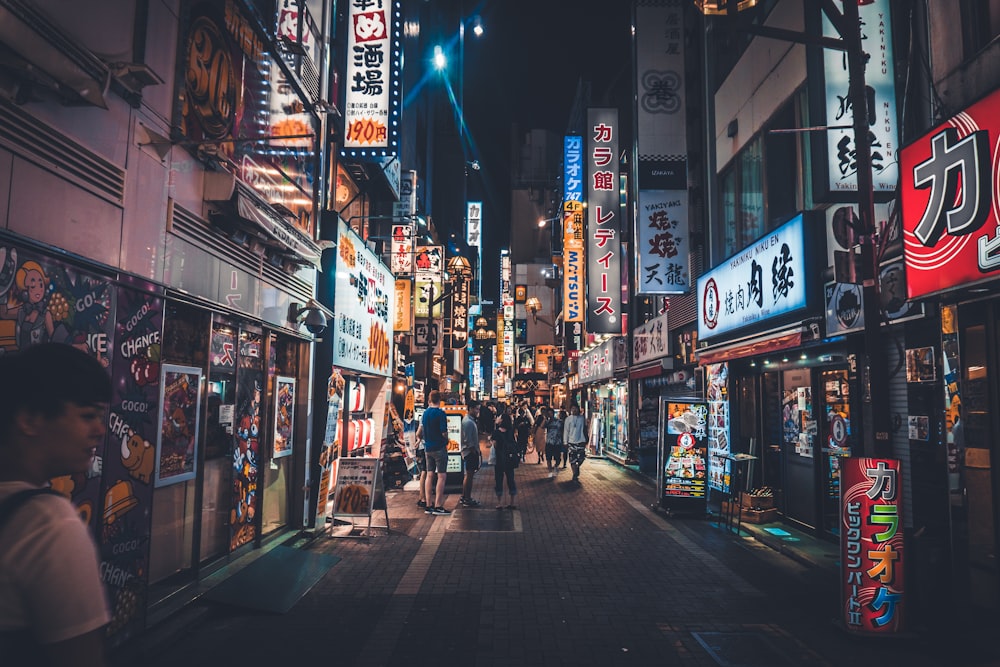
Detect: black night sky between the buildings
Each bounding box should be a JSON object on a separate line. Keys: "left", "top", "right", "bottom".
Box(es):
{"left": 456, "top": 0, "right": 631, "bottom": 298}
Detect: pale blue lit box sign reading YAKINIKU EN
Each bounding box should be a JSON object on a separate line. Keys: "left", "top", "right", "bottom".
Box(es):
{"left": 698, "top": 214, "right": 808, "bottom": 340}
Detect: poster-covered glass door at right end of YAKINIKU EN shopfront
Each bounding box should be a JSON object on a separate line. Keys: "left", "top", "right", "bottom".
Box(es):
{"left": 819, "top": 368, "right": 854, "bottom": 535}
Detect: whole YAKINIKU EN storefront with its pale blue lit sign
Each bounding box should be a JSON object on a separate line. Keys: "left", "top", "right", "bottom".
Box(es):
{"left": 698, "top": 215, "right": 854, "bottom": 534}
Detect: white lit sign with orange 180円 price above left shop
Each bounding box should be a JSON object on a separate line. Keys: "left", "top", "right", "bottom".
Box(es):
{"left": 332, "top": 220, "right": 396, "bottom": 376}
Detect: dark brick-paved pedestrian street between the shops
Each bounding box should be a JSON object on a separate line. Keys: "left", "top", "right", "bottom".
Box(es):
{"left": 114, "top": 460, "right": 1000, "bottom": 667}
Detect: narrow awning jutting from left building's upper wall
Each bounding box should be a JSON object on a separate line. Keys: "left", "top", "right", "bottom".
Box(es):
{"left": 205, "top": 172, "right": 322, "bottom": 268}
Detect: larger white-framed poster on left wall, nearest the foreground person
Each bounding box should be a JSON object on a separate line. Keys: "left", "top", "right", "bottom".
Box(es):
{"left": 156, "top": 364, "right": 201, "bottom": 487}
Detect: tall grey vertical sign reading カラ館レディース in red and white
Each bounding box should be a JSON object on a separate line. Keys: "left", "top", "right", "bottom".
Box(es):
{"left": 586, "top": 109, "right": 622, "bottom": 334}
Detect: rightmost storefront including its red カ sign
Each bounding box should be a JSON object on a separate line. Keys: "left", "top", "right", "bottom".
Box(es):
{"left": 900, "top": 91, "right": 1000, "bottom": 609}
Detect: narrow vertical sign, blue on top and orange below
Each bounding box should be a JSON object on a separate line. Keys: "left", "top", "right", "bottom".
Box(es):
{"left": 563, "top": 135, "right": 586, "bottom": 322}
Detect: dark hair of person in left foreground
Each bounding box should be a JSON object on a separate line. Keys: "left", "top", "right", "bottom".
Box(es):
{"left": 0, "top": 343, "right": 111, "bottom": 433}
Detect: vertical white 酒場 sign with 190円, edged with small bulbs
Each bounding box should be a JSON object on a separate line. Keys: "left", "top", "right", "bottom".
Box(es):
{"left": 343, "top": 0, "right": 401, "bottom": 157}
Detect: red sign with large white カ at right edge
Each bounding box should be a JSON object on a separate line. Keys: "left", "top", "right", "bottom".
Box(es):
{"left": 900, "top": 91, "right": 1000, "bottom": 299}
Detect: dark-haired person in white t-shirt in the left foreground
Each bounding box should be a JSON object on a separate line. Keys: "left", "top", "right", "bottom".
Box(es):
{"left": 0, "top": 343, "right": 111, "bottom": 667}
